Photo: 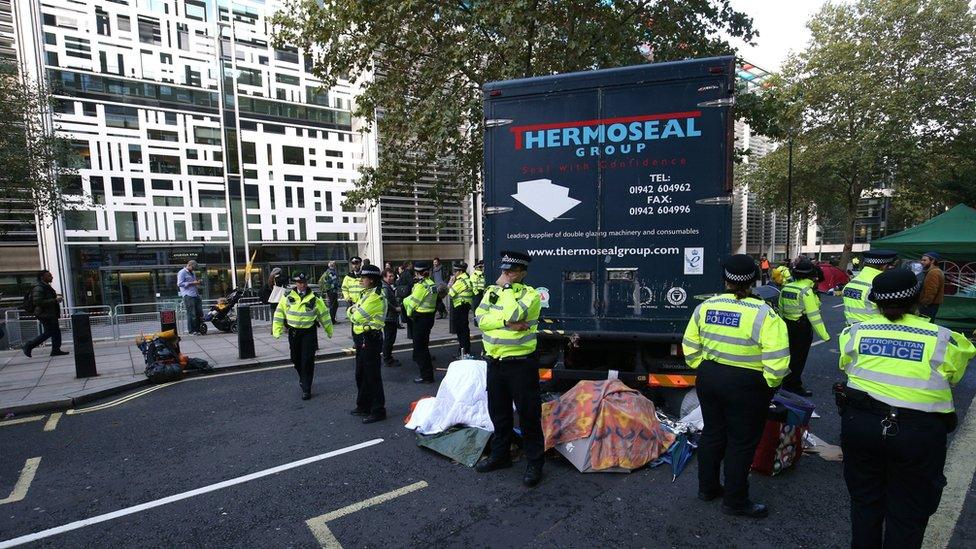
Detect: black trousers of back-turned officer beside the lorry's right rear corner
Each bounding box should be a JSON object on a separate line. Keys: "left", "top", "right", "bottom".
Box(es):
{"left": 697, "top": 360, "right": 773, "bottom": 508}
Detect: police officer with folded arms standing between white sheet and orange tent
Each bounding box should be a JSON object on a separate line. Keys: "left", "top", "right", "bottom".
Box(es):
{"left": 476, "top": 251, "right": 545, "bottom": 488}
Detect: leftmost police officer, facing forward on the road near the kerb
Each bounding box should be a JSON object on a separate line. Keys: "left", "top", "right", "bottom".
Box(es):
{"left": 271, "top": 273, "right": 332, "bottom": 400}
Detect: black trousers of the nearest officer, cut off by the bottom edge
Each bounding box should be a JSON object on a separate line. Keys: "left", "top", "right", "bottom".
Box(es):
{"left": 840, "top": 407, "right": 946, "bottom": 548}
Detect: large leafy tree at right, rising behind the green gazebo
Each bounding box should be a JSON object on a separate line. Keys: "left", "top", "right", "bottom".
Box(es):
{"left": 745, "top": 0, "right": 976, "bottom": 265}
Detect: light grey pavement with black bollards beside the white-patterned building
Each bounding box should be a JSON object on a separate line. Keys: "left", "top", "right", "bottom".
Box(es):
{"left": 0, "top": 310, "right": 472, "bottom": 419}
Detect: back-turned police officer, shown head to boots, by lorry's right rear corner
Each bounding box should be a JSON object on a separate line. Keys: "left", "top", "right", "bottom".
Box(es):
{"left": 681, "top": 254, "right": 790, "bottom": 518}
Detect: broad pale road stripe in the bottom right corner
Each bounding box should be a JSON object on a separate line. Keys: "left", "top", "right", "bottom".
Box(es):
{"left": 922, "top": 392, "right": 976, "bottom": 549}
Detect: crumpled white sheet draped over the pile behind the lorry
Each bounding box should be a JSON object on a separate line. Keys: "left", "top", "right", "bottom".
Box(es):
{"left": 406, "top": 360, "right": 495, "bottom": 435}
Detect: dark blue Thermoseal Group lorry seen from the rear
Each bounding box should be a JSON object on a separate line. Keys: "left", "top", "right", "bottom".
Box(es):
{"left": 483, "top": 57, "right": 735, "bottom": 387}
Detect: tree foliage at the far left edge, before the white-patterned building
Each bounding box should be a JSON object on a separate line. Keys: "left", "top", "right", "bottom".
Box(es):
{"left": 0, "top": 64, "right": 76, "bottom": 235}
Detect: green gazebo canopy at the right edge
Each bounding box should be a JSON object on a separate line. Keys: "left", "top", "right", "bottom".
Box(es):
{"left": 871, "top": 204, "right": 976, "bottom": 262}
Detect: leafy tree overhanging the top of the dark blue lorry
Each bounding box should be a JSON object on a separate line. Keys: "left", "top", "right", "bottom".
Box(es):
{"left": 274, "top": 0, "right": 755, "bottom": 210}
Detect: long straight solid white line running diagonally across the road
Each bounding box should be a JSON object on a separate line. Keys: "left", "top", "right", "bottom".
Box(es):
{"left": 0, "top": 438, "right": 383, "bottom": 549}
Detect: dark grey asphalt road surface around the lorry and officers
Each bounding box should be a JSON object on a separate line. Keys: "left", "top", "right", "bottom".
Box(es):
{"left": 0, "top": 298, "right": 976, "bottom": 547}
